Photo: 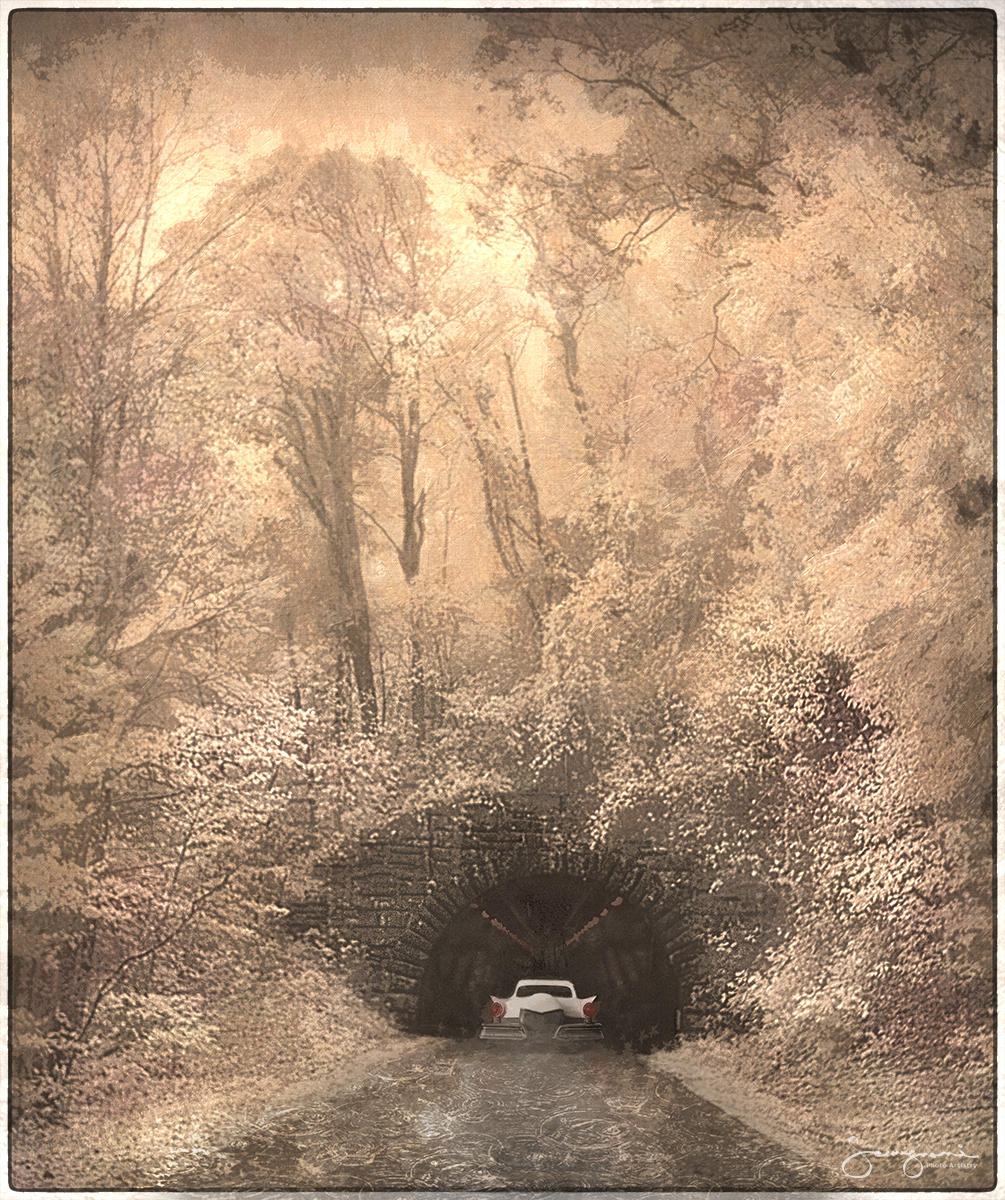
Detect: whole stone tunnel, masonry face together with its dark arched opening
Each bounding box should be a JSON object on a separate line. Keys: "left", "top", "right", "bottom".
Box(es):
{"left": 284, "top": 792, "right": 772, "bottom": 1050}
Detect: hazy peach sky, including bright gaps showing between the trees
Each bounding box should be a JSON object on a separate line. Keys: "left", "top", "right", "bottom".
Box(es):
{"left": 11, "top": 10, "right": 621, "bottom": 614}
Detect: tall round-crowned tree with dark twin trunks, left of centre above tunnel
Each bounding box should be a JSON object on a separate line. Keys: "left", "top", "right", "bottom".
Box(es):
{"left": 209, "top": 150, "right": 477, "bottom": 731}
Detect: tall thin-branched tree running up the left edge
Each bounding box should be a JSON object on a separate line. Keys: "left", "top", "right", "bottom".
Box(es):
{"left": 12, "top": 21, "right": 279, "bottom": 1104}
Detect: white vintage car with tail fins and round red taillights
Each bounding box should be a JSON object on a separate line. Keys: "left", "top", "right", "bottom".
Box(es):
{"left": 479, "top": 979, "right": 603, "bottom": 1043}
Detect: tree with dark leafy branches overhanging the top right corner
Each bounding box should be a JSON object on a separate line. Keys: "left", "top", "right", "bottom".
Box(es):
{"left": 477, "top": 12, "right": 991, "bottom": 454}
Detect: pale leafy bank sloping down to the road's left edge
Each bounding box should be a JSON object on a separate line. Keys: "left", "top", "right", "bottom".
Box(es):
{"left": 10, "top": 943, "right": 428, "bottom": 1190}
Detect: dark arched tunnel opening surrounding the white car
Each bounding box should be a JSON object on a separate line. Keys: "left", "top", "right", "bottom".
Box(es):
{"left": 416, "top": 872, "right": 680, "bottom": 1051}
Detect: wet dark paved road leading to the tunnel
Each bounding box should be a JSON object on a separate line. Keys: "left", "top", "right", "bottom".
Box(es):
{"left": 158, "top": 1042, "right": 834, "bottom": 1192}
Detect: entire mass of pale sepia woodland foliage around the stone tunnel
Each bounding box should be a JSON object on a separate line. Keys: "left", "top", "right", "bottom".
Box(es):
{"left": 12, "top": 11, "right": 993, "bottom": 1142}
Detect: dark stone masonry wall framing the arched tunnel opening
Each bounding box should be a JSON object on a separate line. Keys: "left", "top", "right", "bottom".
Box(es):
{"left": 285, "top": 793, "right": 777, "bottom": 1026}
